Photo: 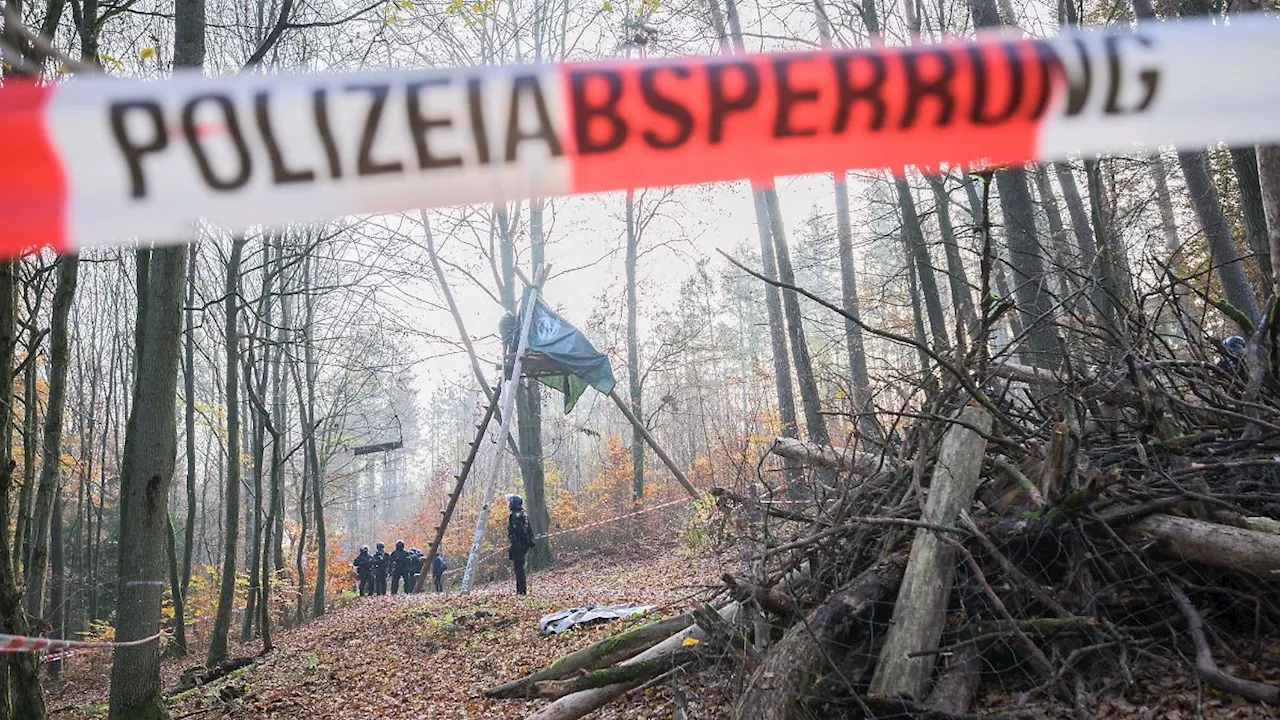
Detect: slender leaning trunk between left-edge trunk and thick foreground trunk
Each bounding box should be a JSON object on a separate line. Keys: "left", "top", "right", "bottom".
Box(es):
{"left": 24, "top": 254, "right": 79, "bottom": 618}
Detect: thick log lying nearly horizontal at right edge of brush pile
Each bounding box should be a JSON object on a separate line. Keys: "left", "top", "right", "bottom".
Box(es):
{"left": 1123, "top": 515, "right": 1280, "bottom": 580}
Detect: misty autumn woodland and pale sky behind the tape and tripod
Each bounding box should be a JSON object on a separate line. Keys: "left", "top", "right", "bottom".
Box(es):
{"left": 0, "top": 0, "right": 1280, "bottom": 719}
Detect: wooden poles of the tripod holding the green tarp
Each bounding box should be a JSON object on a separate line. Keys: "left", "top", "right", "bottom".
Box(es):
{"left": 413, "top": 265, "right": 701, "bottom": 594}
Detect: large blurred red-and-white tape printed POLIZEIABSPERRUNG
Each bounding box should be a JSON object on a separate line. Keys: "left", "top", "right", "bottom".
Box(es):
{"left": 0, "top": 15, "right": 1280, "bottom": 256}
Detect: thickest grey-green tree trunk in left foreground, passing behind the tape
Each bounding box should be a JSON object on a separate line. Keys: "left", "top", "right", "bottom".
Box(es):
{"left": 110, "top": 242, "right": 187, "bottom": 720}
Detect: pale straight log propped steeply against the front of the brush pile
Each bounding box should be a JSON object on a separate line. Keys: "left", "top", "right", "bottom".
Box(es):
{"left": 869, "top": 406, "right": 992, "bottom": 700}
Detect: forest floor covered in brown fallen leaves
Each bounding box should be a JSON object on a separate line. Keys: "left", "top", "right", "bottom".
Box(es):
{"left": 35, "top": 538, "right": 1280, "bottom": 720}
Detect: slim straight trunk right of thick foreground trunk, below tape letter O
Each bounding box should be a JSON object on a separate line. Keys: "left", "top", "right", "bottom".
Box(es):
{"left": 205, "top": 237, "right": 244, "bottom": 667}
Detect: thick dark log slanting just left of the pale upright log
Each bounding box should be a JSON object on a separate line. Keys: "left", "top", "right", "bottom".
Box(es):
{"left": 733, "top": 556, "right": 905, "bottom": 720}
